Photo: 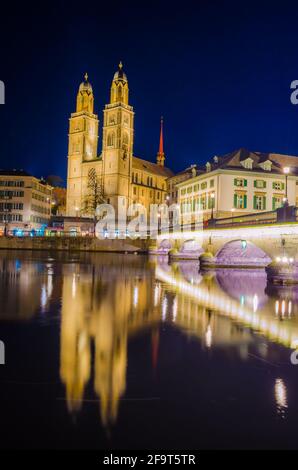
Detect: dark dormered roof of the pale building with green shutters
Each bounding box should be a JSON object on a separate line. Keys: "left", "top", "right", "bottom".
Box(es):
{"left": 198, "top": 148, "right": 298, "bottom": 175}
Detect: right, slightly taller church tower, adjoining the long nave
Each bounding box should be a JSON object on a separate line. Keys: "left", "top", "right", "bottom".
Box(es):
{"left": 102, "top": 62, "right": 134, "bottom": 211}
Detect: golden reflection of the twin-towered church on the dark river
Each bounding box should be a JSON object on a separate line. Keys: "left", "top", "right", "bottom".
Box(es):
{"left": 60, "top": 255, "right": 159, "bottom": 426}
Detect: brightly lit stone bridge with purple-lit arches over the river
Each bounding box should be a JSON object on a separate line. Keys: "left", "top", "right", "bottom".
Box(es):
{"left": 150, "top": 223, "right": 298, "bottom": 267}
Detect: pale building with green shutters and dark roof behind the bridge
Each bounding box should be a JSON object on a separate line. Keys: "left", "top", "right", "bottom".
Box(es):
{"left": 177, "top": 149, "right": 298, "bottom": 219}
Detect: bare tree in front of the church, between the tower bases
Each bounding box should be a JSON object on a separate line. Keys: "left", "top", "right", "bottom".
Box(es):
{"left": 82, "top": 168, "right": 105, "bottom": 233}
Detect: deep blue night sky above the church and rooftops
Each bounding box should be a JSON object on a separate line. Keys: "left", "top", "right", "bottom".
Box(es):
{"left": 0, "top": 0, "right": 298, "bottom": 183}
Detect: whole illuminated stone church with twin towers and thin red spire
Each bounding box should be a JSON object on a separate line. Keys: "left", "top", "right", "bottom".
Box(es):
{"left": 66, "top": 62, "right": 172, "bottom": 216}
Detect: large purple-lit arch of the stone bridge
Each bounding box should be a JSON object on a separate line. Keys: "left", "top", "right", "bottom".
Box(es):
{"left": 215, "top": 240, "right": 271, "bottom": 268}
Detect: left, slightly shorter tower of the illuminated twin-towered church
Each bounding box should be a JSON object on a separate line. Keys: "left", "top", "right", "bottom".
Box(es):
{"left": 66, "top": 74, "right": 98, "bottom": 216}
